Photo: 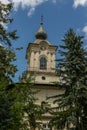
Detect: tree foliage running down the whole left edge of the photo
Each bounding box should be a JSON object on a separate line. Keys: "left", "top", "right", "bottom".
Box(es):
{"left": 0, "top": 2, "right": 21, "bottom": 130}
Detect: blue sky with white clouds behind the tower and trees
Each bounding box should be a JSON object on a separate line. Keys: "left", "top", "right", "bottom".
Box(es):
{"left": 0, "top": 0, "right": 87, "bottom": 82}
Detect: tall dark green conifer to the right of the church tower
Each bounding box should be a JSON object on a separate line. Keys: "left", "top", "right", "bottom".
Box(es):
{"left": 51, "top": 29, "right": 87, "bottom": 130}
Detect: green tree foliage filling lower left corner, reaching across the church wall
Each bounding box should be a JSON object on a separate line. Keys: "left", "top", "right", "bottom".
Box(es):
{"left": 0, "top": 76, "right": 42, "bottom": 130}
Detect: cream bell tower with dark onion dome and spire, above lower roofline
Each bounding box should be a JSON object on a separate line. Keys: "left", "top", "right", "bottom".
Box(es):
{"left": 26, "top": 17, "right": 58, "bottom": 84}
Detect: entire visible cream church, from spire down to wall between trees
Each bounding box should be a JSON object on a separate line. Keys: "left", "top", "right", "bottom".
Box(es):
{"left": 26, "top": 18, "right": 62, "bottom": 130}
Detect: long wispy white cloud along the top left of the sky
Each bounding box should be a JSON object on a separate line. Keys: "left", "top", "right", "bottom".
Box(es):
{"left": 0, "top": 0, "right": 57, "bottom": 16}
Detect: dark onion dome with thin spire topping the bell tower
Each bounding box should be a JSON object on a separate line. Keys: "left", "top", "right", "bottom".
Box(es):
{"left": 35, "top": 17, "right": 47, "bottom": 40}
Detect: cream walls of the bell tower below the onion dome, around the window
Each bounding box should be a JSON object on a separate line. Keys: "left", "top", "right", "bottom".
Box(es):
{"left": 27, "top": 40, "right": 58, "bottom": 84}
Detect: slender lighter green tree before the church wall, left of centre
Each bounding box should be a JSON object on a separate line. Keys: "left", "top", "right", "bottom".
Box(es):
{"left": 22, "top": 75, "right": 43, "bottom": 130}
